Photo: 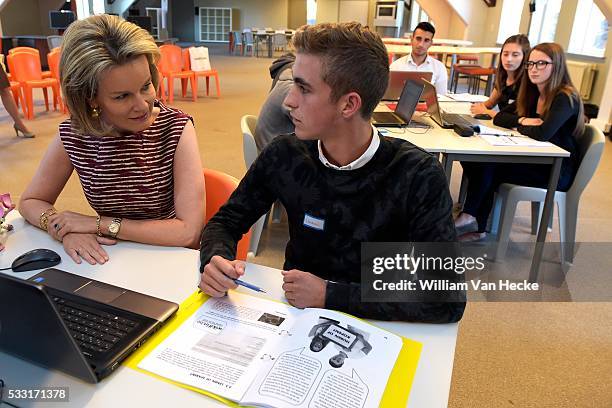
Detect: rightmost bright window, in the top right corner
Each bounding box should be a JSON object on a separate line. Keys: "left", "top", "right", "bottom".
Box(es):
{"left": 567, "top": 0, "right": 608, "bottom": 57}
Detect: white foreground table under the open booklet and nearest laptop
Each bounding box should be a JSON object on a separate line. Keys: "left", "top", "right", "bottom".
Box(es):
{"left": 0, "top": 213, "right": 458, "bottom": 408}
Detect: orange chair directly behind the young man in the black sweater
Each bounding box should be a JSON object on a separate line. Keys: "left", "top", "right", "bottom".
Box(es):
{"left": 204, "top": 169, "right": 251, "bottom": 261}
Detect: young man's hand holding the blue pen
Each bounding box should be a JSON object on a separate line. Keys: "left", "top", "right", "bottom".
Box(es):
{"left": 199, "top": 255, "right": 245, "bottom": 297}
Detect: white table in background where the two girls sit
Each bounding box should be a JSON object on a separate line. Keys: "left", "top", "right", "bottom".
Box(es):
{"left": 388, "top": 107, "right": 570, "bottom": 282}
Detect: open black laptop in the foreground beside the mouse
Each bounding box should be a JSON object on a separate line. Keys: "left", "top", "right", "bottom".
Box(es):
{"left": 0, "top": 268, "right": 178, "bottom": 383}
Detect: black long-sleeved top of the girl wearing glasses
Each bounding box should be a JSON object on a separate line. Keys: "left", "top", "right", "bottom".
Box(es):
{"left": 493, "top": 92, "right": 582, "bottom": 190}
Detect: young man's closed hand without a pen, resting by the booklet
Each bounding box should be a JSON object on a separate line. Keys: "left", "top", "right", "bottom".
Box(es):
{"left": 281, "top": 269, "right": 327, "bottom": 309}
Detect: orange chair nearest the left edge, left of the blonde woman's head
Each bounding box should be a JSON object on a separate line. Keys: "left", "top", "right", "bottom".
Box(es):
{"left": 7, "top": 52, "right": 59, "bottom": 119}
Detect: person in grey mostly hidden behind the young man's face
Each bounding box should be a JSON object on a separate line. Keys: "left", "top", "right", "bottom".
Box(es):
{"left": 253, "top": 53, "right": 295, "bottom": 152}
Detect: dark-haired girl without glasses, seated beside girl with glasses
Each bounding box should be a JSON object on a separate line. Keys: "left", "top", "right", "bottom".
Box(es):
{"left": 470, "top": 34, "right": 530, "bottom": 118}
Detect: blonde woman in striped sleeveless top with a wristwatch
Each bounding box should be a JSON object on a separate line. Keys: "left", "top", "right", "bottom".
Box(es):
{"left": 19, "top": 14, "right": 205, "bottom": 264}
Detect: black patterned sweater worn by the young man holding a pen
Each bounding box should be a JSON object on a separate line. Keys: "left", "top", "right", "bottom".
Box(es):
{"left": 200, "top": 135, "right": 465, "bottom": 323}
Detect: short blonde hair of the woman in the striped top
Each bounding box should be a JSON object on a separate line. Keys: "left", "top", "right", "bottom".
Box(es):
{"left": 60, "top": 14, "right": 160, "bottom": 136}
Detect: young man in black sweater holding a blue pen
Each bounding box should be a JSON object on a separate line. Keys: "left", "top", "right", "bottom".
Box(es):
{"left": 199, "top": 23, "right": 465, "bottom": 323}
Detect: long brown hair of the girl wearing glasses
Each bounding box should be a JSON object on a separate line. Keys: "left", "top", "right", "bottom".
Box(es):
{"left": 516, "top": 43, "right": 584, "bottom": 136}
